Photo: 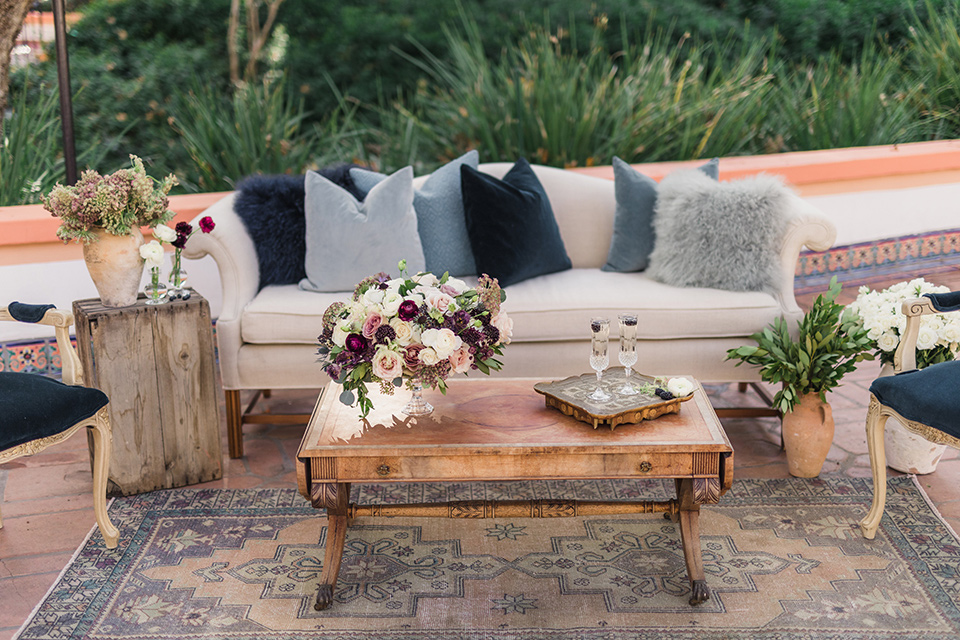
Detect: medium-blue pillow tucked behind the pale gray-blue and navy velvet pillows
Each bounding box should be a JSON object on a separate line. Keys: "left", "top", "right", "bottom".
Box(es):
{"left": 350, "top": 151, "right": 480, "bottom": 276}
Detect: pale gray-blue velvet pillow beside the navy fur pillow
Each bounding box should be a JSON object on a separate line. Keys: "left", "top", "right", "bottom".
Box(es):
{"left": 300, "top": 167, "right": 425, "bottom": 292}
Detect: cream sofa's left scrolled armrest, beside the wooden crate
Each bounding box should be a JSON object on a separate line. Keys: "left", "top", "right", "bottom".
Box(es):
{"left": 183, "top": 193, "right": 260, "bottom": 389}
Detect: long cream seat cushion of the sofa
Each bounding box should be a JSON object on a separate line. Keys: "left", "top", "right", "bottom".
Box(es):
{"left": 241, "top": 269, "right": 781, "bottom": 350}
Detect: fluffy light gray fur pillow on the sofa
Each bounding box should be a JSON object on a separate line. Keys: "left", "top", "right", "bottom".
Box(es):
{"left": 647, "top": 170, "right": 790, "bottom": 292}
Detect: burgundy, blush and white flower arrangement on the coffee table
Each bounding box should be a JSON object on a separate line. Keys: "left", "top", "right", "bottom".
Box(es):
{"left": 318, "top": 261, "right": 513, "bottom": 417}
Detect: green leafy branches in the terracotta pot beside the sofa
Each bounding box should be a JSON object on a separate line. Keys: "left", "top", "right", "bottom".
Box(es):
{"left": 727, "top": 276, "right": 874, "bottom": 413}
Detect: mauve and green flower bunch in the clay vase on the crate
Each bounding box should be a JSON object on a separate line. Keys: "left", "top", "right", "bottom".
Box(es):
{"left": 43, "top": 155, "right": 177, "bottom": 243}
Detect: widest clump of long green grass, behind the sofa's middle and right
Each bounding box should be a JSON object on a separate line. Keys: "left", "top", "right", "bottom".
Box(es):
{"left": 386, "top": 18, "right": 771, "bottom": 167}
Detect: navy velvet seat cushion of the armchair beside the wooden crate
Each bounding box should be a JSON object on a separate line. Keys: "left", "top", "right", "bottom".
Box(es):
{"left": 0, "top": 371, "right": 109, "bottom": 451}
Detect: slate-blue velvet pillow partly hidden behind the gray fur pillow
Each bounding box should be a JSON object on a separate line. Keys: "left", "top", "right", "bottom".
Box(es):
{"left": 601, "top": 156, "right": 720, "bottom": 272}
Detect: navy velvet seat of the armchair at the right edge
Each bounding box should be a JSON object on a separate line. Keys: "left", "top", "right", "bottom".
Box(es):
{"left": 870, "top": 360, "right": 960, "bottom": 438}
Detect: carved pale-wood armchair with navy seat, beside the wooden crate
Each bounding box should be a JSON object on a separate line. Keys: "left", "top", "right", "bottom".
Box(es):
{"left": 0, "top": 302, "right": 120, "bottom": 549}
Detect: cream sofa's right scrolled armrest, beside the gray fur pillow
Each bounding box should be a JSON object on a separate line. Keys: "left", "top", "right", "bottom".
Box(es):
{"left": 774, "top": 195, "right": 837, "bottom": 313}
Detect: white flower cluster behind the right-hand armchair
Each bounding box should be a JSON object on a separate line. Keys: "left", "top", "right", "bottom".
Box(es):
{"left": 847, "top": 278, "right": 960, "bottom": 369}
